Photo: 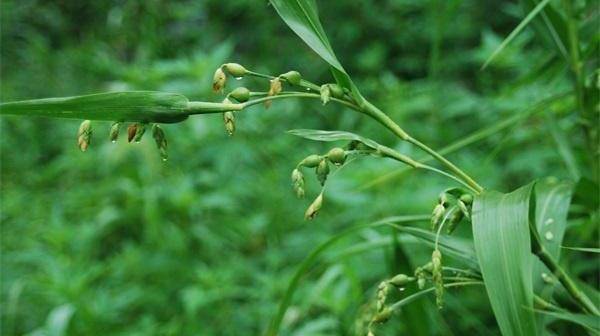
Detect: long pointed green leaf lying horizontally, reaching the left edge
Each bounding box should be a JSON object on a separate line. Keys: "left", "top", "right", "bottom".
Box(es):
{"left": 0, "top": 91, "right": 188, "bottom": 123}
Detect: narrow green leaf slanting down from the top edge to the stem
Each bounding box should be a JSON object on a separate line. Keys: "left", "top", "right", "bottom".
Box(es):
{"left": 270, "top": 0, "right": 363, "bottom": 103}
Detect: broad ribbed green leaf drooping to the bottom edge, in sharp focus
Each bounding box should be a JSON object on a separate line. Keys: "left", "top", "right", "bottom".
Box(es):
{"left": 472, "top": 184, "right": 536, "bottom": 336}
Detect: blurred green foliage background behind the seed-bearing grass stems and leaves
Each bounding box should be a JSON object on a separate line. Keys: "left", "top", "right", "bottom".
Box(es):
{"left": 0, "top": 0, "right": 598, "bottom": 336}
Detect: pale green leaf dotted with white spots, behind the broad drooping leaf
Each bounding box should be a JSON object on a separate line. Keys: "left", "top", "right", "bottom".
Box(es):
{"left": 533, "top": 179, "right": 573, "bottom": 295}
